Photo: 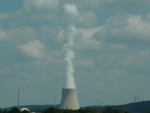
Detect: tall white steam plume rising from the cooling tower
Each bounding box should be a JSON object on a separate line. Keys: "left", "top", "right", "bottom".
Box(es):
{"left": 63, "top": 4, "right": 79, "bottom": 88}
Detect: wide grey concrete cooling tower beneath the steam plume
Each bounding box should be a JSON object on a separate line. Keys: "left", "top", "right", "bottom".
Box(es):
{"left": 59, "top": 89, "right": 79, "bottom": 110}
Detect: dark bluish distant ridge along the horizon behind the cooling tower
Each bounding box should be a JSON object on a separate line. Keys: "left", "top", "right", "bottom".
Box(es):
{"left": 3, "top": 101, "right": 150, "bottom": 113}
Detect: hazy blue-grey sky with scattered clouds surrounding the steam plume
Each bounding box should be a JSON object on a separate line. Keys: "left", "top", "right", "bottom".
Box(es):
{"left": 0, "top": 0, "right": 150, "bottom": 108}
